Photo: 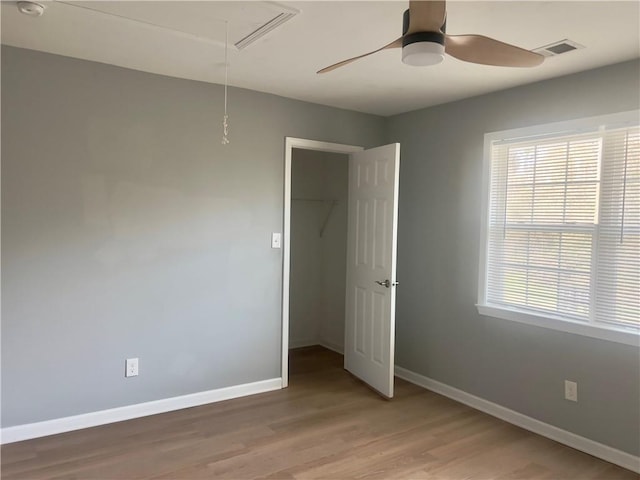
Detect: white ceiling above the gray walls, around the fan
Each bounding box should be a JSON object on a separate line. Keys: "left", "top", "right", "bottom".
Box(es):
{"left": 1, "top": 1, "right": 640, "bottom": 115}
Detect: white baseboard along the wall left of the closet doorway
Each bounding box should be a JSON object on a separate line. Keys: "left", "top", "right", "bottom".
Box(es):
{"left": 0, "top": 378, "right": 282, "bottom": 444}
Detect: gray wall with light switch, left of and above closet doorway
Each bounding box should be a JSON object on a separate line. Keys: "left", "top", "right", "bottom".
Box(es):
{"left": 2, "top": 47, "right": 385, "bottom": 427}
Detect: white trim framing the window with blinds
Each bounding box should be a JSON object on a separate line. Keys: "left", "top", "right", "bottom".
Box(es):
{"left": 476, "top": 110, "right": 640, "bottom": 347}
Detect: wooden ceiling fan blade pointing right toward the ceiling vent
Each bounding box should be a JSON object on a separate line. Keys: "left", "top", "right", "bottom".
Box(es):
{"left": 445, "top": 35, "right": 544, "bottom": 67}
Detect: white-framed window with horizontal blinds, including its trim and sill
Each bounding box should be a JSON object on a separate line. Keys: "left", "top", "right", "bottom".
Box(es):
{"left": 478, "top": 112, "right": 640, "bottom": 344}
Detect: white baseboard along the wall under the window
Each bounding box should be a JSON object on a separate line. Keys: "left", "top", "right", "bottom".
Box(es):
{"left": 395, "top": 365, "right": 640, "bottom": 473}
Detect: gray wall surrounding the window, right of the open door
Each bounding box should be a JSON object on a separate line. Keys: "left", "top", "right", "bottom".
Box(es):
{"left": 387, "top": 61, "right": 640, "bottom": 455}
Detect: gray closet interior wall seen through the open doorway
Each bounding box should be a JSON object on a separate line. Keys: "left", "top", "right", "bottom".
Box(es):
{"left": 289, "top": 149, "right": 349, "bottom": 351}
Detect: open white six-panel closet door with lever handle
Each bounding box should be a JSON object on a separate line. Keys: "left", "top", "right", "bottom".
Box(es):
{"left": 344, "top": 143, "right": 400, "bottom": 398}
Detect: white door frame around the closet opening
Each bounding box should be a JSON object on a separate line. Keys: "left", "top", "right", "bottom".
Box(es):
{"left": 281, "top": 137, "right": 364, "bottom": 388}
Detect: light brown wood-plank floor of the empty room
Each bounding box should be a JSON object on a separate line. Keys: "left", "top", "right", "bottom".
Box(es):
{"left": 1, "top": 347, "right": 639, "bottom": 480}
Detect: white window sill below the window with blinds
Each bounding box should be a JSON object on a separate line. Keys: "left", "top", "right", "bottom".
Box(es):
{"left": 476, "top": 305, "right": 640, "bottom": 347}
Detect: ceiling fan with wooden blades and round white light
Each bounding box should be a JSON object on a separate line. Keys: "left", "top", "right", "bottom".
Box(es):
{"left": 317, "top": 0, "right": 544, "bottom": 73}
